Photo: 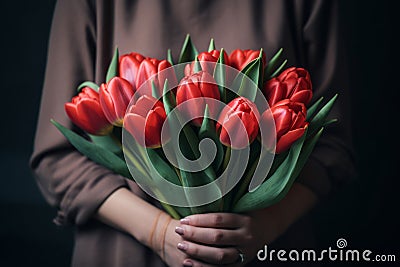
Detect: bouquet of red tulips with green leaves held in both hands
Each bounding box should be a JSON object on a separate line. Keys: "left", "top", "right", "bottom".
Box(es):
{"left": 52, "top": 36, "right": 336, "bottom": 218}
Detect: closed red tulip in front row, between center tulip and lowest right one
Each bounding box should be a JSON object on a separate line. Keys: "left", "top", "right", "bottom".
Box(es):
{"left": 216, "top": 97, "right": 260, "bottom": 149}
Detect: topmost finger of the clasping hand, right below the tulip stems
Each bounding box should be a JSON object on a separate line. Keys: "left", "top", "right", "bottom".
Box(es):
{"left": 181, "top": 213, "right": 249, "bottom": 229}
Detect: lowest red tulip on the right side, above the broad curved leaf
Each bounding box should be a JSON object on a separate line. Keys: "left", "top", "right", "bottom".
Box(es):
{"left": 261, "top": 99, "right": 308, "bottom": 154}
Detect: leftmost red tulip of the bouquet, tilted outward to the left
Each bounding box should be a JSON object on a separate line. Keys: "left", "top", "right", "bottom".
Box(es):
{"left": 64, "top": 87, "right": 113, "bottom": 135}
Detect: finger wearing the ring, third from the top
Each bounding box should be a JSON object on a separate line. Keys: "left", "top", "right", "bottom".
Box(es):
{"left": 177, "top": 241, "right": 239, "bottom": 264}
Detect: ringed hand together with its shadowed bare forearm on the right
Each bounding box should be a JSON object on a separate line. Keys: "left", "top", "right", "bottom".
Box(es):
{"left": 175, "top": 184, "right": 316, "bottom": 267}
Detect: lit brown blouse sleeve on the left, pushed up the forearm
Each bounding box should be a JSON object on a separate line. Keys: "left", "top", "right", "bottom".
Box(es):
{"left": 30, "top": 0, "right": 133, "bottom": 225}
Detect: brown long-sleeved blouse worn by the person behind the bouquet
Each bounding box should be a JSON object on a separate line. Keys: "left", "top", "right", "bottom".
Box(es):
{"left": 31, "top": 0, "right": 353, "bottom": 266}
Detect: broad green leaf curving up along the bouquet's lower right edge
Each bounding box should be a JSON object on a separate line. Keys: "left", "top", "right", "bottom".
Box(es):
{"left": 233, "top": 126, "right": 323, "bottom": 212}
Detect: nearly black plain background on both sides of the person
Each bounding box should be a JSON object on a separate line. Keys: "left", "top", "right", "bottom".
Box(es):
{"left": 0, "top": 0, "right": 400, "bottom": 266}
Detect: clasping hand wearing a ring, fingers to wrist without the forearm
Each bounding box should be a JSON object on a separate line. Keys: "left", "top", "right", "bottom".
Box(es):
{"left": 175, "top": 212, "right": 280, "bottom": 266}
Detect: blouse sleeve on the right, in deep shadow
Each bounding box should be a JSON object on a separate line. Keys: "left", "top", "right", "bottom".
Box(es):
{"left": 296, "top": 0, "right": 355, "bottom": 196}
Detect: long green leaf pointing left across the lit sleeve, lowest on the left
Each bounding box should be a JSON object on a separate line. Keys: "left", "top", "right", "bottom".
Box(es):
{"left": 51, "top": 120, "right": 132, "bottom": 179}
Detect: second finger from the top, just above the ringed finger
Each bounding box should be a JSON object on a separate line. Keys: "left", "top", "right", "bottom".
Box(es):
{"left": 175, "top": 225, "right": 245, "bottom": 246}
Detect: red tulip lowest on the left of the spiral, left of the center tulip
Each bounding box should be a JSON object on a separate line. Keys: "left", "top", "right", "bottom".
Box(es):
{"left": 124, "top": 95, "right": 167, "bottom": 148}
